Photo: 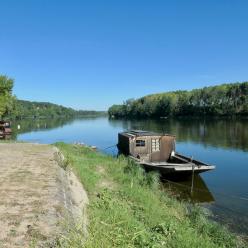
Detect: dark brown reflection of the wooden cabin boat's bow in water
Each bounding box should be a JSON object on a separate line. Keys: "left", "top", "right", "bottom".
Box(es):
{"left": 163, "top": 175, "right": 215, "bottom": 203}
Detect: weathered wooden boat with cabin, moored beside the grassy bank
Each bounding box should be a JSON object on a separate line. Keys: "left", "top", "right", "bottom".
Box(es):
{"left": 117, "top": 130, "right": 215, "bottom": 176}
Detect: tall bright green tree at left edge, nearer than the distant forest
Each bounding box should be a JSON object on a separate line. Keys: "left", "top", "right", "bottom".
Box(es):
{"left": 0, "top": 75, "right": 14, "bottom": 119}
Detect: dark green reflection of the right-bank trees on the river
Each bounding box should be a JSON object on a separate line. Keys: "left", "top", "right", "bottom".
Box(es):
{"left": 109, "top": 118, "right": 248, "bottom": 151}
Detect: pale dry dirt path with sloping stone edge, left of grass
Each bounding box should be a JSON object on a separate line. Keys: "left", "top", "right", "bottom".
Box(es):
{"left": 0, "top": 144, "right": 88, "bottom": 248}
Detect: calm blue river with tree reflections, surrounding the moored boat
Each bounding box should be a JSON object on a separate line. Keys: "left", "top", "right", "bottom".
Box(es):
{"left": 7, "top": 117, "right": 248, "bottom": 235}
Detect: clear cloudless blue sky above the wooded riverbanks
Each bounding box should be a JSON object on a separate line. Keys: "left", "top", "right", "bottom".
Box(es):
{"left": 0, "top": 0, "right": 248, "bottom": 110}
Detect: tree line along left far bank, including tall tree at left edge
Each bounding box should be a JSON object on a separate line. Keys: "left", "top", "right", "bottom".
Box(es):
{"left": 0, "top": 75, "right": 105, "bottom": 119}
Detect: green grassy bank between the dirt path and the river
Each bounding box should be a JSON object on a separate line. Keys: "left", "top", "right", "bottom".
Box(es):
{"left": 56, "top": 143, "right": 245, "bottom": 248}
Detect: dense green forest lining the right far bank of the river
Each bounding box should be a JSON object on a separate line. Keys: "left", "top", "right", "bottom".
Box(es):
{"left": 108, "top": 82, "right": 248, "bottom": 118}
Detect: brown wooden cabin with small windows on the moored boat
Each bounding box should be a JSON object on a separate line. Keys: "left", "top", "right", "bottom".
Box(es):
{"left": 118, "top": 130, "right": 175, "bottom": 162}
